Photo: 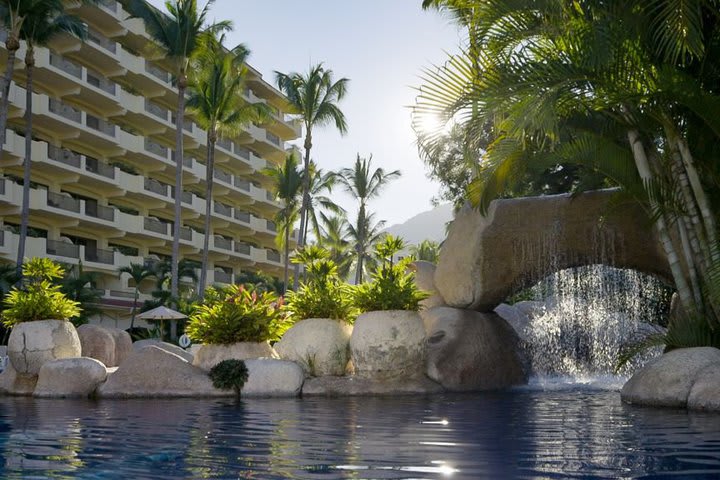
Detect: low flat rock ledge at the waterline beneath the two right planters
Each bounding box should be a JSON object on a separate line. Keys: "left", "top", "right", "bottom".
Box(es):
{"left": 302, "top": 376, "right": 444, "bottom": 397}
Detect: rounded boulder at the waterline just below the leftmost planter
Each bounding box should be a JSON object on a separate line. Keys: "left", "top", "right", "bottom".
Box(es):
{"left": 33, "top": 357, "right": 107, "bottom": 398}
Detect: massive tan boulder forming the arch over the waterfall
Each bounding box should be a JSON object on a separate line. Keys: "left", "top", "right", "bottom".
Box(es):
{"left": 434, "top": 190, "right": 672, "bottom": 312}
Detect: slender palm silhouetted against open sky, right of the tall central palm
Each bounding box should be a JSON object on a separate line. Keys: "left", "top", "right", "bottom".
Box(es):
{"left": 338, "top": 154, "right": 400, "bottom": 284}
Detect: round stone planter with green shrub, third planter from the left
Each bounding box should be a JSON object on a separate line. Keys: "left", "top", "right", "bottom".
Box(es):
{"left": 275, "top": 246, "right": 357, "bottom": 376}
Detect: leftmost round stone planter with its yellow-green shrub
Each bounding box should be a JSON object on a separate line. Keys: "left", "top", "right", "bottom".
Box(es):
{"left": 2, "top": 258, "right": 81, "bottom": 375}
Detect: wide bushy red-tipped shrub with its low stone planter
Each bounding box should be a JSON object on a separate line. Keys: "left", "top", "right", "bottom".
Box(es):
{"left": 185, "top": 285, "right": 288, "bottom": 371}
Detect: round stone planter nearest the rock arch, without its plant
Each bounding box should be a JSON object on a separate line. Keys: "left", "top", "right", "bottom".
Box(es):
{"left": 350, "top": 310, "right": 425, "bottom": 380}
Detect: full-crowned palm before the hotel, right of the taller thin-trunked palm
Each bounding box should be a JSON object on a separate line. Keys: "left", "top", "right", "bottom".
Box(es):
{"left": 187, "top": 33, "right": 269, "bottom": 298}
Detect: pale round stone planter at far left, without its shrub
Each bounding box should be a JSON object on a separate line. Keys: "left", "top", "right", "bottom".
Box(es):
{"left": 8, "top": 320, "right": 82, "bottom": 375}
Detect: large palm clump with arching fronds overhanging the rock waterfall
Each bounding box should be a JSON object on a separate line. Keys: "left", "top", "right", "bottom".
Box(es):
{"left": 415, "top": 0, "right": 720, "bottom": 347}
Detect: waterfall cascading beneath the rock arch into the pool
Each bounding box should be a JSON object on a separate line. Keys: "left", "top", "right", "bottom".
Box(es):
{"left": 506, "top": 224, "right": 670, "bottom": 388}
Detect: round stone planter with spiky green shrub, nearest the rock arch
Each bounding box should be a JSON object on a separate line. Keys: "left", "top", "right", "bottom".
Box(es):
{"left": 350, "top": 235, "right": 427, "bottom": 378}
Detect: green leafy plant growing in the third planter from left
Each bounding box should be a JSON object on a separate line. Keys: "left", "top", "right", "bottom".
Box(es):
{"left": 285, "top": 245, "right": 357, "bottom": 322}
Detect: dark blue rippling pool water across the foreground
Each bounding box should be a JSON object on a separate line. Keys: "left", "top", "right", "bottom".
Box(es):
{"left": 0, "top": 385, "right": 720, "bottom": 479}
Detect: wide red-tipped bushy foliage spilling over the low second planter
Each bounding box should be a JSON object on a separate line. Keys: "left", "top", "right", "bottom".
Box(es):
{"left": 186, "top": 285, "right": 288, "bottom": 345}
